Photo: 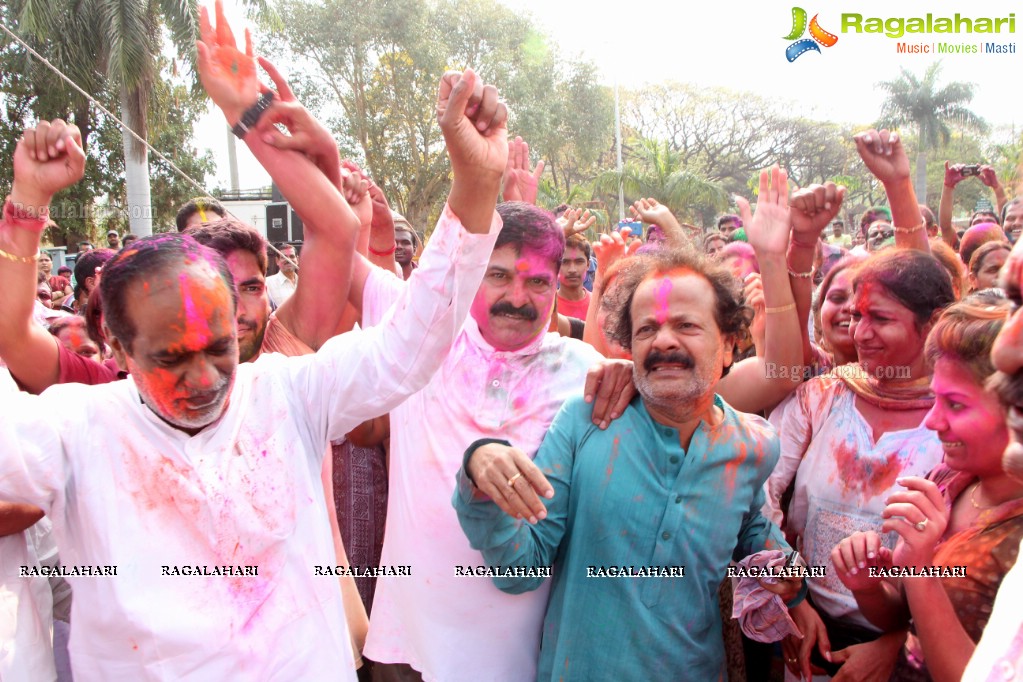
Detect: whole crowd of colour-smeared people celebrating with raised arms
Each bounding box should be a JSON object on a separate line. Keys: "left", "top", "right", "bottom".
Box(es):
{"left": 0, "top": 2, "right": 1023, "bottom": 682}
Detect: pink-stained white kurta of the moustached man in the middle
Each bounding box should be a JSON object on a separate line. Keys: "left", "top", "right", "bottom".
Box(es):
{"left": 363, "top": 275, "right": 602, "bottom": 682}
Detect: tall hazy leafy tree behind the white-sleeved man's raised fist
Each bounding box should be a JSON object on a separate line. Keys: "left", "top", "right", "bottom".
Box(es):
{"left": 264, "top": 0, "right": 611, "bottom": 227}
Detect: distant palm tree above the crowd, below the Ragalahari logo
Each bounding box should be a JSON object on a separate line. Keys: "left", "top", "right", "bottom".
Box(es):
{"left": 878, "top": 62, "right": 987, "bottom": 203}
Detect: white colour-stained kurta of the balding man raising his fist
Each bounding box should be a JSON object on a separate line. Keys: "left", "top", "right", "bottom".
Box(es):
{"left": 0, "top": 209, "right": 500, "bottom": 682}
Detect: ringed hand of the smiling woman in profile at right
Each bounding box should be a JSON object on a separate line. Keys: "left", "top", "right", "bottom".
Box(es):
{"left": 881, "top": 476, "right": 948, "bottom": 567}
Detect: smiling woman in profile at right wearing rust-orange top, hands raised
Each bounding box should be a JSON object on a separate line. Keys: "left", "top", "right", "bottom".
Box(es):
{"left": 832, "top": 292, "right": 1023, "bottom": 682}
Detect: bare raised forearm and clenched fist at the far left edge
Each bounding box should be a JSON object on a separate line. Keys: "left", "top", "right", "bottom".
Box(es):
{"left": 0, "top": 119, "right": 85, "bottom": 393}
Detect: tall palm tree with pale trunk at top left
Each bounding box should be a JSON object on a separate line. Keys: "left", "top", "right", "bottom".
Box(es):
{"left": 10, "top": 0, "right": 273, "bottom": 236}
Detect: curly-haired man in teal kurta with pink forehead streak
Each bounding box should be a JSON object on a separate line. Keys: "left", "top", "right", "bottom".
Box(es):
{"left": 453, "top": 244, "right": 802, "bottom": 680}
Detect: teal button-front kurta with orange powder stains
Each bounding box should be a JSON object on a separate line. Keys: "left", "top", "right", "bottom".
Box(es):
{"left": 453, "top": 396, "right": 789, "bottom": 681}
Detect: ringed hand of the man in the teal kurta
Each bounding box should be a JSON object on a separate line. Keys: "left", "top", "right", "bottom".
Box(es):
{"left": 465, "top": 443, "right": 554, "bottom": 524}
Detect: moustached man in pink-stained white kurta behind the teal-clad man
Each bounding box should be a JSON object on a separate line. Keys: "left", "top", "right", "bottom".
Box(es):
{"left": 353, "top": 201, "right": 601, "bottom": 682}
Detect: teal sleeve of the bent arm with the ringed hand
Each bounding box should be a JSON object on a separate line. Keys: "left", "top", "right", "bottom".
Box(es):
{"left": 451, "top": 402, "right": 589, "bottom": 594}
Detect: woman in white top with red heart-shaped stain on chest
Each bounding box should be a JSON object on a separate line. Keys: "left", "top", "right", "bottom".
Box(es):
{"left": 767, "top": 248, "right": 953, "bottom": 675}
